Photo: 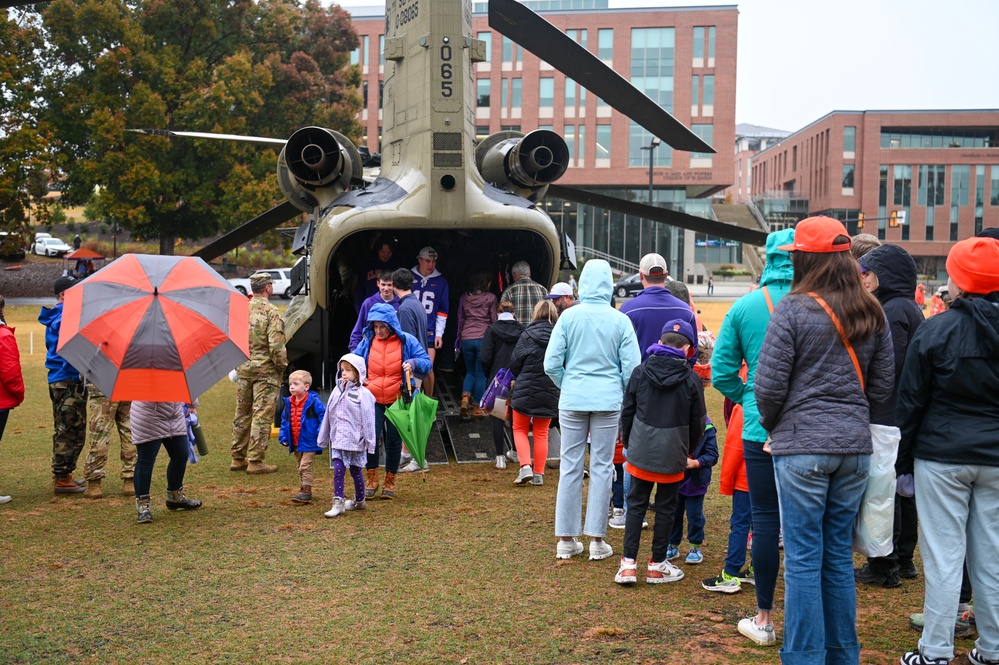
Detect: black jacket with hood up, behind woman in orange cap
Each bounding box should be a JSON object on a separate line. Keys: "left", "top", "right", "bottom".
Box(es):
{"left": 860, "top": 245, "right": 926, "bottom": 425}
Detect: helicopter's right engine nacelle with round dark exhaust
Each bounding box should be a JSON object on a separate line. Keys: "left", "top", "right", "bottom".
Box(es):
{"left": 475, "top": 129, "right": 569, "bottom": 201}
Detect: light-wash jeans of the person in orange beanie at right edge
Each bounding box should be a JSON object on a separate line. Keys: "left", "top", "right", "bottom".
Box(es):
{"left": 913, "top": 459, "right": 999, "bottom": 660}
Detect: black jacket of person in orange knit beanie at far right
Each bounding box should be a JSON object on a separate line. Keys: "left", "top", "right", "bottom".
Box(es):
{"left": 895, "top": 292, "right": 999, "bottom": 473}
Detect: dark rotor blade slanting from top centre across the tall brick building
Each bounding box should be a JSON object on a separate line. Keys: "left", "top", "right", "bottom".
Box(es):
{"left": 489, "top": 0, "right": 715, "bottom": 152}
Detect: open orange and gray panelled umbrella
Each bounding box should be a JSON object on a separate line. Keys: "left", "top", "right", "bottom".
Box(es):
{"left": 58, "top": 254, "right": 250, "bottom": 402}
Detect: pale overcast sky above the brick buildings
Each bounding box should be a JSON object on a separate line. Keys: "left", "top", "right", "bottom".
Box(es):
{"left": 341, "top": 0, "right": 999, "bottom": 131}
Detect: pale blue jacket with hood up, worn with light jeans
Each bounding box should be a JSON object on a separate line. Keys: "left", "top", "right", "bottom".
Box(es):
{"left": 544, "top": 259, "right": 642, "bottom": 411}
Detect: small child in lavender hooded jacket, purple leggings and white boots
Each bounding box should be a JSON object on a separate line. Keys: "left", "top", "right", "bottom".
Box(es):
{"left": 319, "top": 353, "right": 375, "bottom": 517}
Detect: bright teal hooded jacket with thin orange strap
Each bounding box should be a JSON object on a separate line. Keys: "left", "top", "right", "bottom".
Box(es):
{"left": 711, "top": 229, "right": 794, "bottom": 441}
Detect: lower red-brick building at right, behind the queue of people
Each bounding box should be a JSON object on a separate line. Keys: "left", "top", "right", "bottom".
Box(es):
{"left": 751, "top": 110, "right": 999, "bottom": 279}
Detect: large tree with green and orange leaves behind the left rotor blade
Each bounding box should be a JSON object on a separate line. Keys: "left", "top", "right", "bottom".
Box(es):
{"left": 44, "top": 0, "right": 361, "bottom": 253}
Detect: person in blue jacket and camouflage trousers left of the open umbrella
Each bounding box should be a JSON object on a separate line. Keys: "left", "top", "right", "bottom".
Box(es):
{"left": 38, "top": 277, "right": 87, "bottom": 494}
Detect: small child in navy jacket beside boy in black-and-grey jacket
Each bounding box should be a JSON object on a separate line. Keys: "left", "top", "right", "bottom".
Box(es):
{"left": 666, "top": 418, "right": 718, "bottom": 565}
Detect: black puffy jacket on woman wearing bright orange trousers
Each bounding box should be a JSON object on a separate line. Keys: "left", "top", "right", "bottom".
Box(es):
{"left": 510, "top": 321, "right": 559, "bottom": 418}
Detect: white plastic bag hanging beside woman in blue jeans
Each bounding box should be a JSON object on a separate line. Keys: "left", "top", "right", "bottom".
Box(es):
{"left": 853, "top": 425, "right": 902, "bottom": 557}
